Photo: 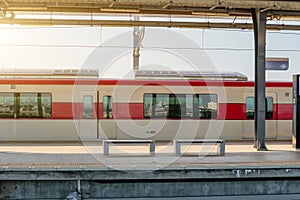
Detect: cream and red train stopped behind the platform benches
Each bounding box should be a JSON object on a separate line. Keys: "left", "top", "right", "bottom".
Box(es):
{"left": 0, "top": 69, "right": 293, "bottom": 141}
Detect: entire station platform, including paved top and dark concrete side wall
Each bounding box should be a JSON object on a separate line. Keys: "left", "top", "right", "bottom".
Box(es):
{"left": 0, "top": 141, "right": 300, "bottom": 199}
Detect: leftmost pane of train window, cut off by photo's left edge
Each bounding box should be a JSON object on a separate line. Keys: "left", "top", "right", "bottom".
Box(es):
{"left": 0, "top": 93, "right": 15, "bottom": 118}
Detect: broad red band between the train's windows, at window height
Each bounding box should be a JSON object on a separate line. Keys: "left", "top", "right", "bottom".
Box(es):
{"left": 52, "top": 102, "right": 293, "bottom": 120}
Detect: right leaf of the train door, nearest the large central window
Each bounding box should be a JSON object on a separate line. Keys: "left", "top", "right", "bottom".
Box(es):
{"left": 98, "top": 91, "right": 117, "bottom": 139}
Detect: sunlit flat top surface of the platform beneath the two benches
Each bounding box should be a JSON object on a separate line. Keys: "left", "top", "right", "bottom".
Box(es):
{"left": 0, "top": 141, "right": 300, "bottom": 170}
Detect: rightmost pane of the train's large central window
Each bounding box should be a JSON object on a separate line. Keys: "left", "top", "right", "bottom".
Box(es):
{"left": 197, "top": 94, "right": 218, "bottom": 119}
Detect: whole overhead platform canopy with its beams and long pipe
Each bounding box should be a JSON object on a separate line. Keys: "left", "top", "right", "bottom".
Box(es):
{"left": 0, "top": 0, "right": 300, "bottom": 30}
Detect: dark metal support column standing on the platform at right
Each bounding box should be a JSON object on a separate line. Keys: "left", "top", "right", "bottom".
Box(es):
{"left": 251, "top": 9, "right": 267, "bottom": 151}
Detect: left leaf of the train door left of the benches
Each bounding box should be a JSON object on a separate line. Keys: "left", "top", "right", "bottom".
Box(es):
{"left": 75, "top": 91, "right": 97, "bottom": 141}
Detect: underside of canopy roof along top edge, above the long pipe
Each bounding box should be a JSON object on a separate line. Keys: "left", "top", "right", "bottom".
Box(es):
{"left": 0, "top": 0, "right": 300, "bottom": 16}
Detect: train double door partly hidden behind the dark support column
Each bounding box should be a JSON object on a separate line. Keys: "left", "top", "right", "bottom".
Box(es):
{"left": 243, "top": 93, "right": 277, "bottom": 139}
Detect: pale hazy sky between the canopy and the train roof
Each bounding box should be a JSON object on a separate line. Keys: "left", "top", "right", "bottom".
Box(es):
{"left": 0, "top": 25, "right": 300, "bottom": 81}
